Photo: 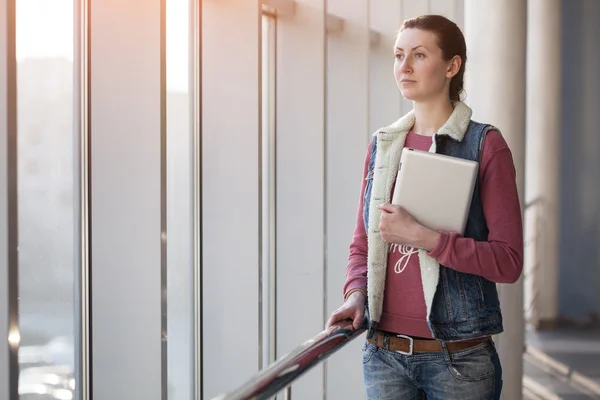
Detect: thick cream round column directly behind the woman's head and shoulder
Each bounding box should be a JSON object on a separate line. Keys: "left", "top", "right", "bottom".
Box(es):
{"left": 465, "top": 0, "right": 527, "bottom": 399}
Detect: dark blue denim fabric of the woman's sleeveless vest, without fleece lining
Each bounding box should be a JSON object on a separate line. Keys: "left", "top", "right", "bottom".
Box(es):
{"left": 363, "top": 121, "right": 503, "bottom": 341}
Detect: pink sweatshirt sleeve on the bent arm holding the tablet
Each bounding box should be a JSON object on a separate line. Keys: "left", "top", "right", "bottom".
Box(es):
{"left": 428, "top": 131, "right": 523, "bottom": 283}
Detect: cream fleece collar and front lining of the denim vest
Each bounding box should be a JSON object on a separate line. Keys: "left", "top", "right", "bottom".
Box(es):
{"left": 367, "top": 102, "right": 472, "bottom": 323}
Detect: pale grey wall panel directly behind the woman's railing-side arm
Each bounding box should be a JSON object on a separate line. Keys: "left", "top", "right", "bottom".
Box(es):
{"left": 325, "top": 0, "right": 369, "bottom": 399}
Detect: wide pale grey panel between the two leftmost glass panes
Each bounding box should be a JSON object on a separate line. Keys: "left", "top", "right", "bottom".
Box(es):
{"left": 90, "top": 0, "right": 166, "bottom": 400}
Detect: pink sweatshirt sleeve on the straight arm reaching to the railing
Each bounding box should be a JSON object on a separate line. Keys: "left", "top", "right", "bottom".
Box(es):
{"left": 343, "top": 141, "right": 372, "bottom": 298}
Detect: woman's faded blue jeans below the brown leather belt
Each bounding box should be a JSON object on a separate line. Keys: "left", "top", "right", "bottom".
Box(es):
{"left": 362, "top": 339, "right": 502, "bottom": 400}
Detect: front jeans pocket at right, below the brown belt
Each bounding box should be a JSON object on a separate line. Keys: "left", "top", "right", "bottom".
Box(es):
{"left": 448, "top": 342, "right": 497, "bottom": 382}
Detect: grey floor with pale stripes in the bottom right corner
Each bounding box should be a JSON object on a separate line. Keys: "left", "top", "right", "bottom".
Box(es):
{"left": 523, "top": 329, "right": 600, "bottom": 400}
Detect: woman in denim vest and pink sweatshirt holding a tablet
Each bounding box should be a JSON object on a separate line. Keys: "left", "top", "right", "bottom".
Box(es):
{"left": 327, "top": 15, "right": 523, "bottom": 400}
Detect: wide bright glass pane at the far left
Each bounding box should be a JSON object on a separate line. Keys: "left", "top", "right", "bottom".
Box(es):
{"left": 16, "top": 0, "right": 76, "bottom": 400}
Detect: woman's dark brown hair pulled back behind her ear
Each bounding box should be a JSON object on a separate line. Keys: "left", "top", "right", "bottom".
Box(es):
{"left": 398, "top": 15, "right": 467, "bottom": 101}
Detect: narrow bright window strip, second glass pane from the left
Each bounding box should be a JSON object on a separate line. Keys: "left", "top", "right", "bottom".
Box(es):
{"left": 166, "top": 0, "right": 194, "bottom": 400}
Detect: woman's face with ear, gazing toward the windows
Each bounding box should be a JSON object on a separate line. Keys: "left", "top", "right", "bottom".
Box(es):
{"left": 394, "top": 29, "right": 460, "bottom": 102}
